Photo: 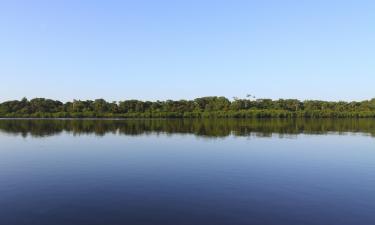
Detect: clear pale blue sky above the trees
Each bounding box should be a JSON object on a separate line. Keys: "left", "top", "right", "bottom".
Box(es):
{"left": 0, "top": 0, "right": 375, "bottom": 101}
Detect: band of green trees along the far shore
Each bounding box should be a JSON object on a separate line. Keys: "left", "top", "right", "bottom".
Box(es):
{"left": 0, "top": 97, "right": 375, "bottom": 118}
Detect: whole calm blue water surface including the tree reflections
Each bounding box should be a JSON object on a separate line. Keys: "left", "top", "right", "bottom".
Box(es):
{"left": 0, "top": 120, "right": 375, "bottom": 225}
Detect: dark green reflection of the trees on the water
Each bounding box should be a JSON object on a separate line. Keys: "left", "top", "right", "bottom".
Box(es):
{"left": 0, "top": 119, "right": 375, "bottom": 137}
